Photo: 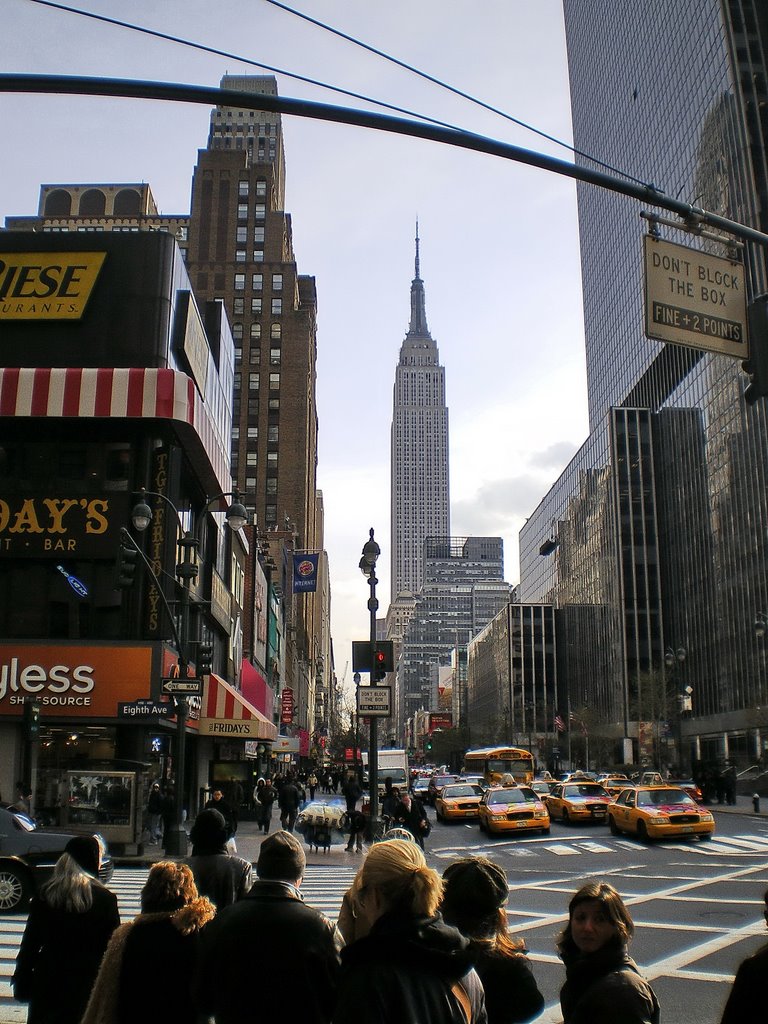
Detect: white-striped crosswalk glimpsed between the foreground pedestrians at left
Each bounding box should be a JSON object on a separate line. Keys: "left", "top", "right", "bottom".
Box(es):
{"left": 0, "top": 864, "right": 356, "bottom": 1024}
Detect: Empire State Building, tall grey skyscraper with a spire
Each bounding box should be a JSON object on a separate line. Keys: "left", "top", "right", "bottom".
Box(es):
{"left": 391, "top": 231, "right": 451, "bottom": 601}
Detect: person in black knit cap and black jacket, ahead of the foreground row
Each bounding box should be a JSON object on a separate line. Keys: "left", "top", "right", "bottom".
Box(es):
{"left": 186, "top": 807, "right": 253, "bottom": 910}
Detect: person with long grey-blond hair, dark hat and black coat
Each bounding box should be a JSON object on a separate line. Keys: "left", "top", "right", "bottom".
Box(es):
{"left": 11, "top": 836, "right": 120, "bottom": 1024}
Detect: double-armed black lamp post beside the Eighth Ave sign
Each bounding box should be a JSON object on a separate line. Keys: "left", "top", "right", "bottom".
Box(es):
{"left": 131, "top": 487, "right": 248, "bottom": 857}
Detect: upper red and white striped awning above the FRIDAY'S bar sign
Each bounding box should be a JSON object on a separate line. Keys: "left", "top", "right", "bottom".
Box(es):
{"left": 0, "top": 367, "right": 231, "bottom": 492}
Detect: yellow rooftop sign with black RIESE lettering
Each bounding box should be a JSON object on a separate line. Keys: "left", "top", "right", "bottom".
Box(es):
{"left": 0, "top": 252, "right": 106, "bottom": 322}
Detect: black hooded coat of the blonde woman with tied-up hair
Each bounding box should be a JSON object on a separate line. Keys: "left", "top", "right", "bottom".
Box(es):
{"left": 333, "top": 911, "right": 487, "bottom": 1024}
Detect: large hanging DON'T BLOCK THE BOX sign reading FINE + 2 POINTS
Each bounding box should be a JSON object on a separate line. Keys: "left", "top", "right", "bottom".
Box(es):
{"left": 644, "top": 234, "right": 750, "bottom": 359}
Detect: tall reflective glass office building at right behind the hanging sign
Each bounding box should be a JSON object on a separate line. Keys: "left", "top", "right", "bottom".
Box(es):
{"left": 519, "top": 0, "right": 768, "bottom": 767}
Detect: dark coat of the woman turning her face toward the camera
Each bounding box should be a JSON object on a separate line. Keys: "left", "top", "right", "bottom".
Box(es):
{"left": 560, "top": 943, "right": 659, "bottom": 1024}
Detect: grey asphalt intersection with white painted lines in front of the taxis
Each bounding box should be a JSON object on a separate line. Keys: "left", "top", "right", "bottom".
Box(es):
{"left": 428, "top": 808, "right": 768, "bottom": 1024}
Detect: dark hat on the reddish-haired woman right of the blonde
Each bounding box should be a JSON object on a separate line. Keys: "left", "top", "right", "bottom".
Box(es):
{"left": 440, "top": 857, "right": 509, "bottom": 934}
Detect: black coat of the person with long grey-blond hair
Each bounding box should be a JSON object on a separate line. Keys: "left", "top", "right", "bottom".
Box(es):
{"left": 12, "top": 881, "right": 120, "bottom": 1024}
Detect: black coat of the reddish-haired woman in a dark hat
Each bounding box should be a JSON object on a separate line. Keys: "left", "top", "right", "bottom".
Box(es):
{"left": 470, "top": 942, "right": 544, "bottom": 1024}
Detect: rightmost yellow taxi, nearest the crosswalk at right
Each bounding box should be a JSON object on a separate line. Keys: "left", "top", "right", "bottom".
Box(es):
{"left": 608, "top": 785, "right": 715, "bottom": 840}
